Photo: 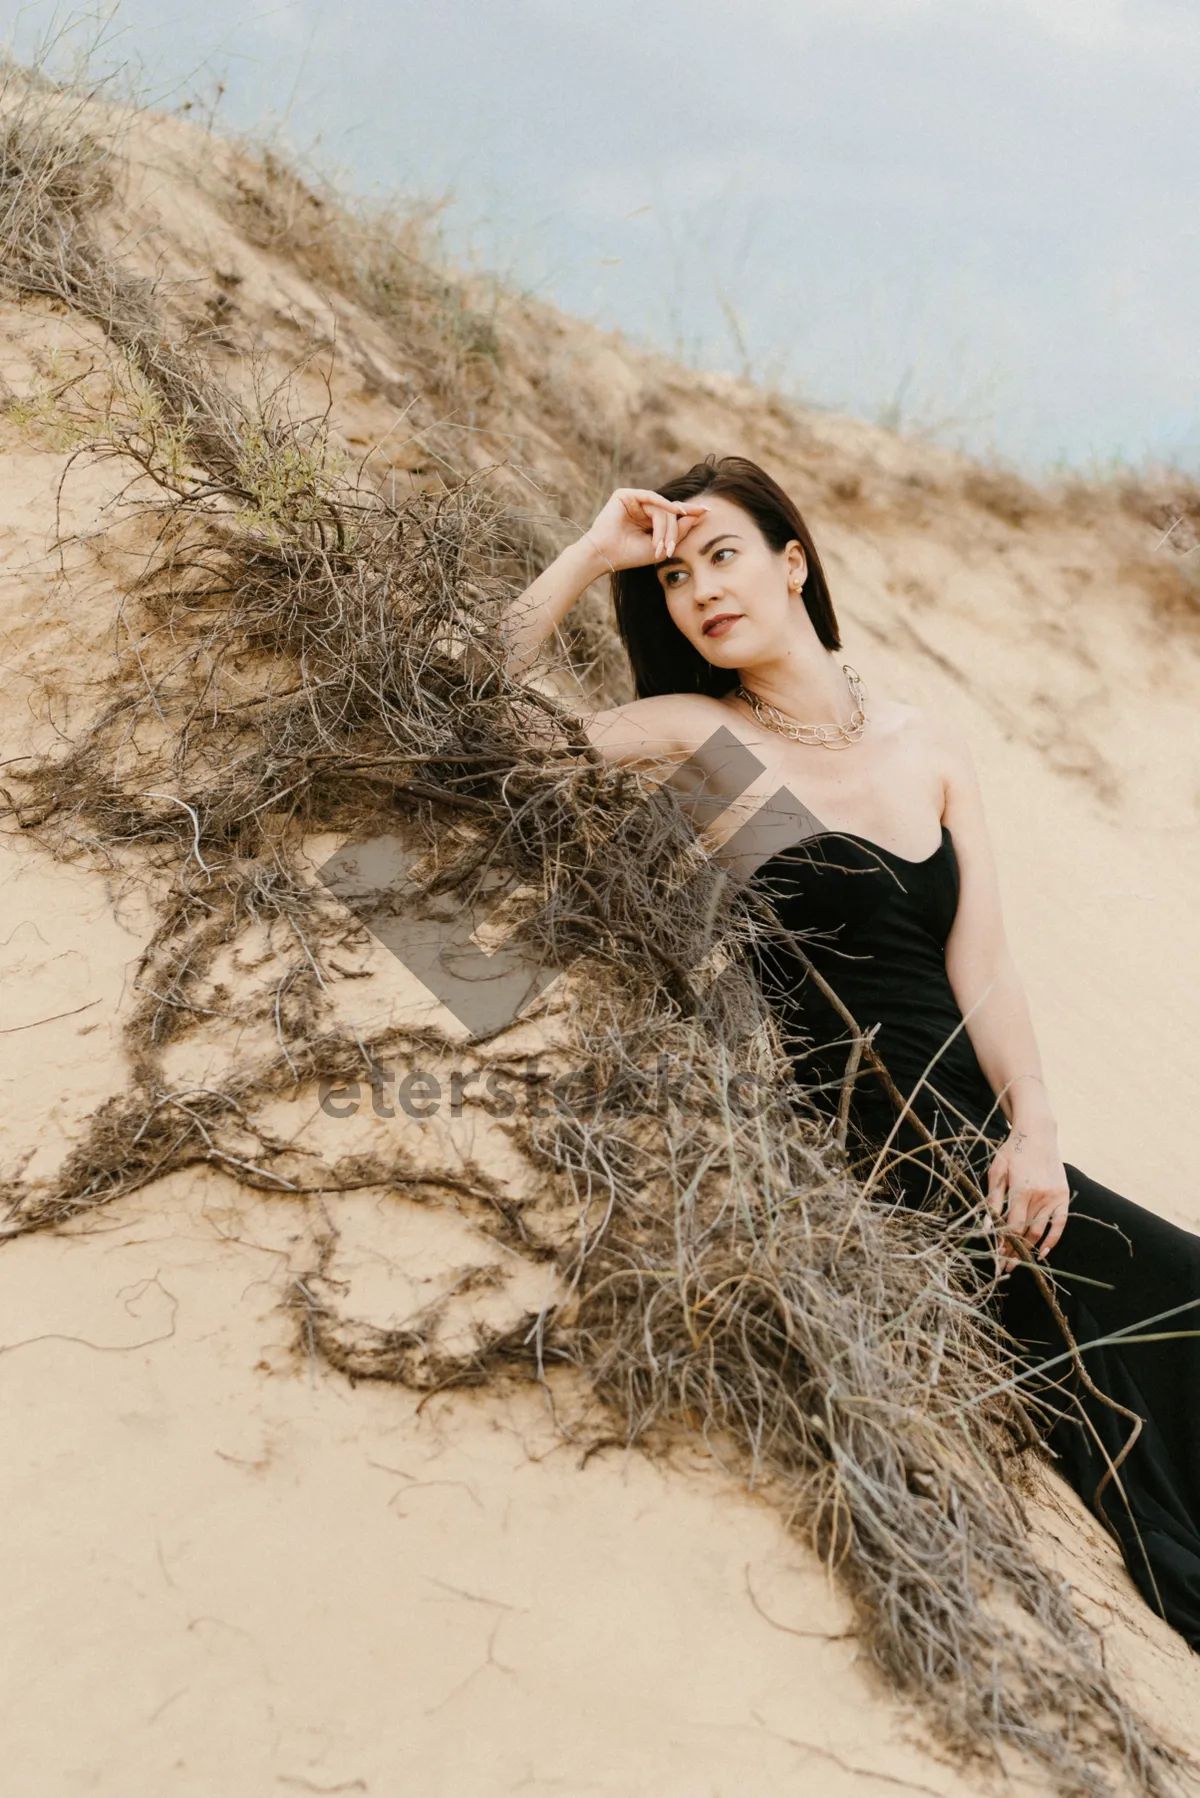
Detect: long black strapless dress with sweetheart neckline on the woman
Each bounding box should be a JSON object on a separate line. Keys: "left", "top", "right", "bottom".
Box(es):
{"left": 743, "top": 820, "right": 1200, "bottom": 1651}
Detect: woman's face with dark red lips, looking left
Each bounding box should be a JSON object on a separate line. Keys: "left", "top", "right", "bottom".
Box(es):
{"left": 657, "top": 494, "right": 806, "bottom": 669}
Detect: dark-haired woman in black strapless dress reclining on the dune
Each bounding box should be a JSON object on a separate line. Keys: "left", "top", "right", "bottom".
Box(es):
{"left": 506, "top": 457, "right": 1200, "bottom": 1649}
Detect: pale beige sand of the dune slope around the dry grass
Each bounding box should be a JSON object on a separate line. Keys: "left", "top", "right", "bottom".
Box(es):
{"left": 0, "top": 102, "right": 1200, "bottom": 1798}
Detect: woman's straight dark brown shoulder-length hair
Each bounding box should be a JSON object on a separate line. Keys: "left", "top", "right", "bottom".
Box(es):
{"left": 612, "top": 455, "right": 842, "bottom": 699}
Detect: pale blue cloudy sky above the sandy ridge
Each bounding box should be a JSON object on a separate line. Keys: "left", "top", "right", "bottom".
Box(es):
{"left": 9, "top": 0, "right": 1200, "bottom": 471}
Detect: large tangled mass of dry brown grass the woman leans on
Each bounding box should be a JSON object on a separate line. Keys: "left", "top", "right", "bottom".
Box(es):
{"left": 0, "top": 63, "right": 1177, "bottom": 1798}
